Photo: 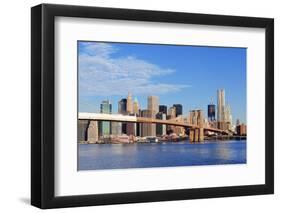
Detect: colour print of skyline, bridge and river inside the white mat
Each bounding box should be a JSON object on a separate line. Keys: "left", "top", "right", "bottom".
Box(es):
{"left": 77, "top": 40, "right": 247, "bottom": 170}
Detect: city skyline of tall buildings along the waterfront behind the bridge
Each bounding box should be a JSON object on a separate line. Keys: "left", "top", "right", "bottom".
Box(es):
{"left": 78, "top": 89, "right": 247, "bottom": 143}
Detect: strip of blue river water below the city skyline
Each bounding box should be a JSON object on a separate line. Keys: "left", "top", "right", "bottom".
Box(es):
{"left": 78, "top": 140, "right": 246, "bottom": 170}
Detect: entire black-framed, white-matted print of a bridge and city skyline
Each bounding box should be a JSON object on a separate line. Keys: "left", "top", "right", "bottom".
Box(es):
{"left": 31, "top": 4, "right": 274, "bottom": 208}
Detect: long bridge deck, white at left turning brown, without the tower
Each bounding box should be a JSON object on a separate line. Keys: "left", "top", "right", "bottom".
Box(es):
{"left": 78, "top": 112, "right": 228, "bottom": 134}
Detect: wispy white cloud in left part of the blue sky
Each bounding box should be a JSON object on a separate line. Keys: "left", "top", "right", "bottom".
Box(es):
{"left": 79, "top": 42, "right": 189, "bottom": 96}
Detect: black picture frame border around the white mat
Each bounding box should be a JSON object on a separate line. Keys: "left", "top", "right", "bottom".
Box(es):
{"left": 31, "top": 4, "right": 274, "bottom": 209}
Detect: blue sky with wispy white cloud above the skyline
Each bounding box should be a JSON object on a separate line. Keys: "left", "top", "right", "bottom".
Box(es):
{"left": 78, "top": 41, "right": 247, "bottom": 122}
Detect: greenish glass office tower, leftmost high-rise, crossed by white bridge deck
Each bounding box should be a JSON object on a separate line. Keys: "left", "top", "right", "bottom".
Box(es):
{"left": 99, "top": 100, "right": 112, "bottom": 136}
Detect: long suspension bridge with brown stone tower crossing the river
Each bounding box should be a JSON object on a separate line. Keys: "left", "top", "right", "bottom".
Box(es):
{"left": 78, "top": 112, "right": 229, "bottom": 142}
